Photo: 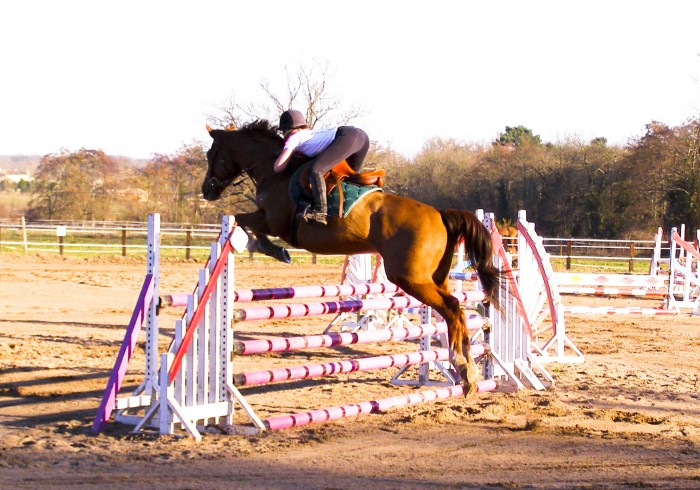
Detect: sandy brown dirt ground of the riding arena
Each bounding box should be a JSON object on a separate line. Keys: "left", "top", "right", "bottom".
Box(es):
{"left": 0, "top": 254, "right": 700, "bottom": 489}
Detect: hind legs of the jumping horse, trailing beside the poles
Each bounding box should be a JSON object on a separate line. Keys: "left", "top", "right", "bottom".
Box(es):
{"left": 390, "top": 278, "right": 478, "bottom": 396}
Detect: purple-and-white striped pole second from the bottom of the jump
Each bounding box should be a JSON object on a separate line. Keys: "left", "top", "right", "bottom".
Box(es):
{"left": 233, "top": 344, "right": 460, "bottom": 387}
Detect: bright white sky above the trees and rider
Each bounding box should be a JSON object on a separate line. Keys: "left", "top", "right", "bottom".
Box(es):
{"left": 0, "top": 0, "right": 700, "bottom": 158}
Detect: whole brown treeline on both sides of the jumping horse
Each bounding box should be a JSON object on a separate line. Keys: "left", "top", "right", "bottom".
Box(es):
{"left": 13, "top": 119, "right": 700, "bottom": 238}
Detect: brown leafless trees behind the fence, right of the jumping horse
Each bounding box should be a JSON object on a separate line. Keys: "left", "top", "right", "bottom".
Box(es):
{"left": 380, "top": 119, "right": 700, "bottom": 238}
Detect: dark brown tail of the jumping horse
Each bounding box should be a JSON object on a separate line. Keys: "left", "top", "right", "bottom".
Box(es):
{"left": 440, "top": 209, "right": 500, "bottom": 308}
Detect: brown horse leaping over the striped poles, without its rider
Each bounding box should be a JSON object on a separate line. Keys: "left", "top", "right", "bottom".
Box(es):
{"left": 202, "top": 121, "right": 499, "bottom": 394}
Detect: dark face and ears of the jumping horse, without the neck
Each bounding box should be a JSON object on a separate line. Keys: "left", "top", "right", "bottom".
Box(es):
{"left": 202, "top": 126, "right": 245, "bottom": 201}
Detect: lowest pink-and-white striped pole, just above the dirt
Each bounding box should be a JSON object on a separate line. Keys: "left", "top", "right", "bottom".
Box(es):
{"left": 263, "top": 379, "right": 497, "bottom": 430}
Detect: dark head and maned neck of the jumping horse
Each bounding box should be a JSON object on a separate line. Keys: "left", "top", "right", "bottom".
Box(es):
{"left": 202, "top": 120, "right": 282, "bottom": 201}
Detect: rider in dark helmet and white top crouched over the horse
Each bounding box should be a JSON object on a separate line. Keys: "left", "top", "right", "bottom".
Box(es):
{"left": 274, "top": 109, "right": 369, "bottom": 225}
